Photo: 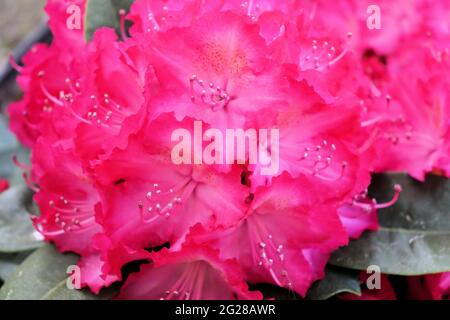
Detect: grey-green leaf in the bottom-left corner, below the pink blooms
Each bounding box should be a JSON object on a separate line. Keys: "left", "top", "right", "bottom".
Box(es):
{"left": 0, "top": 245, "right": 78, "bottom": 300}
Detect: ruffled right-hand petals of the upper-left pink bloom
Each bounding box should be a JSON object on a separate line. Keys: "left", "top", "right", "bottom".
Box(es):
{"left": 71, "top": 28, "right": 146, "bottom": 161}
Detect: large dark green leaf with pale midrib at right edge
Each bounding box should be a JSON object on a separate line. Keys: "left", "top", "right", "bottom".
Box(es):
{"left": 330, "top": 174, "right": 450, "bottom": 276}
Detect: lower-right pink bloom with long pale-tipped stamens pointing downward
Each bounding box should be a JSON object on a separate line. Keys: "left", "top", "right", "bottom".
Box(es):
{"left": 186, "top": 174, "right": 348, "bottom": 295}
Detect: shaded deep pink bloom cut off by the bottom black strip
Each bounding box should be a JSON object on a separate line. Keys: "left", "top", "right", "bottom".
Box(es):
{"left": 118, "top": 243, "right": 262, "bottom": 300}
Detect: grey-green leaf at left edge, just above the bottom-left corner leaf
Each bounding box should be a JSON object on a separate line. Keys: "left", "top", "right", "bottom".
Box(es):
{"left": 0, "top": 186, "right": 42, "bottom": 253}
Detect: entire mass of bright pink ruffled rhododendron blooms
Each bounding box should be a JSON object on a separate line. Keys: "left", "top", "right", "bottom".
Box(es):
{"left": 9, "top": 0, "right": 450, "bottom": 299}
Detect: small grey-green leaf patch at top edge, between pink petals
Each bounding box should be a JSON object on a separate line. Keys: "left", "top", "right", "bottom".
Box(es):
{"left": 85, "top": 0, "right": 133, "bottom": 40}
